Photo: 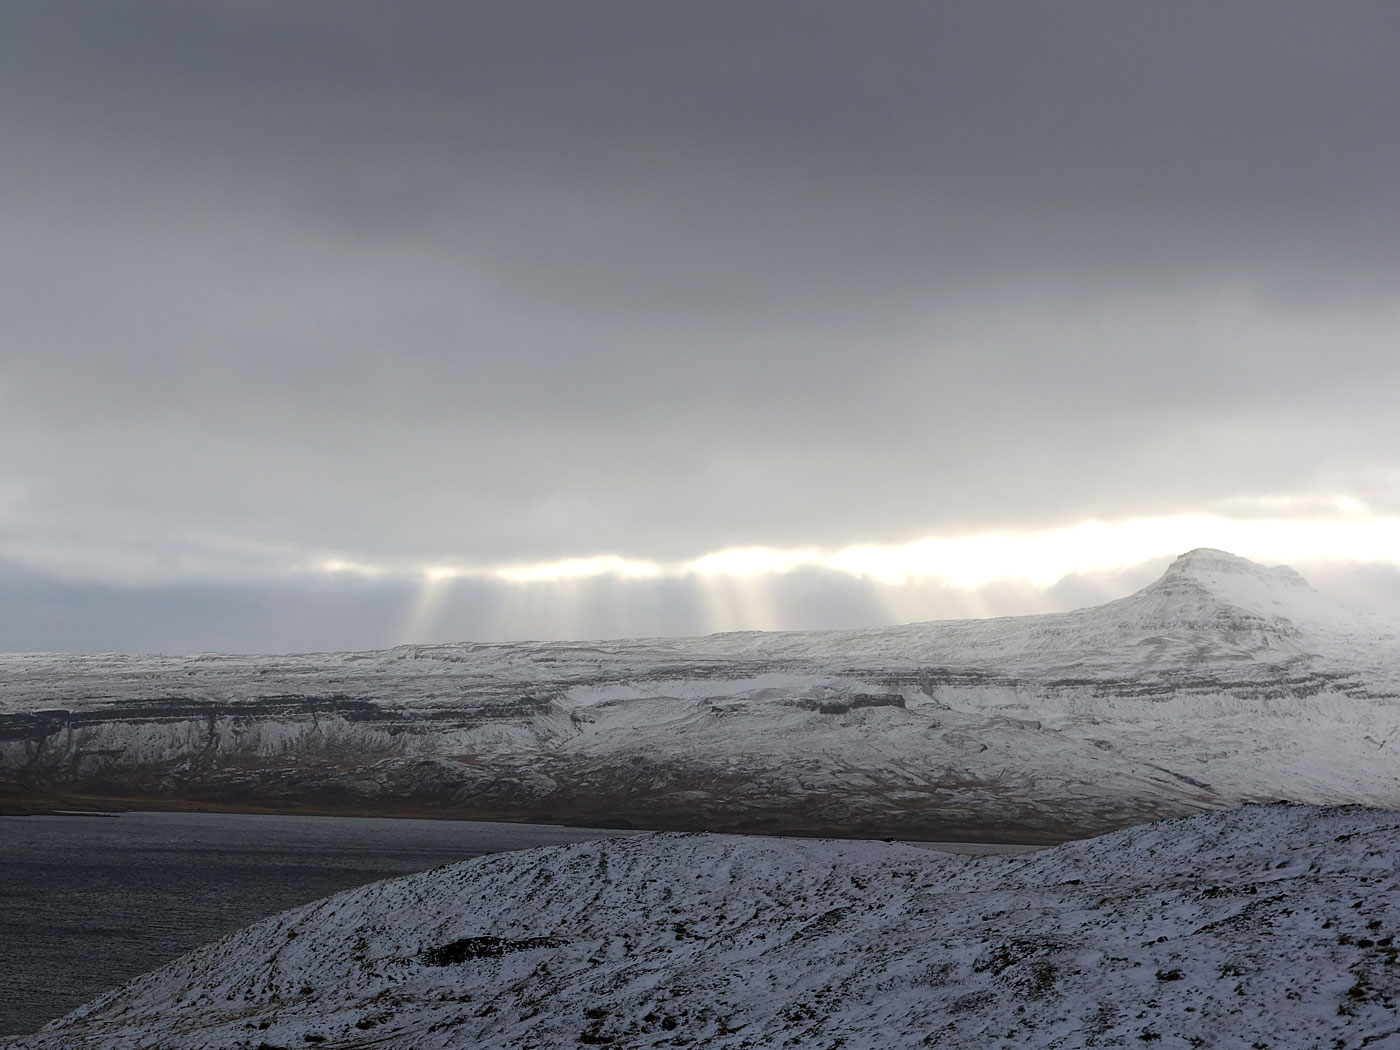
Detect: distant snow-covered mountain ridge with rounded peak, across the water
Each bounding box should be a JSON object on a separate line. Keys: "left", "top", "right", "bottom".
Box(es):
{"left": 0, "top": 550, "right": 1400, "bottom": 841}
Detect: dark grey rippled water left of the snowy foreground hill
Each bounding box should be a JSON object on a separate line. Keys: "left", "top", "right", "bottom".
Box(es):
{"left": 0, "top": 813, "right": 627, "bottom": 1033}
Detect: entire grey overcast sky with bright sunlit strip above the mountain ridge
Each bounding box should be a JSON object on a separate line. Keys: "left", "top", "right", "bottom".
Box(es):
{"left": 0, "top": 0, "right": 1400, "bottom": 651}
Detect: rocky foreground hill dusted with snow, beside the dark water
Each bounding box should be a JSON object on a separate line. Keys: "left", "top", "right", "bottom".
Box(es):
{"left": 0, "top": 805, "right": 1400, "bottom": 1050}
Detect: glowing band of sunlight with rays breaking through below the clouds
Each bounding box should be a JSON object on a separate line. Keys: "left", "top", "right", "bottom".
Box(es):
{"left": 322, "top": 497, "right": 1400, "bottom": 641}
